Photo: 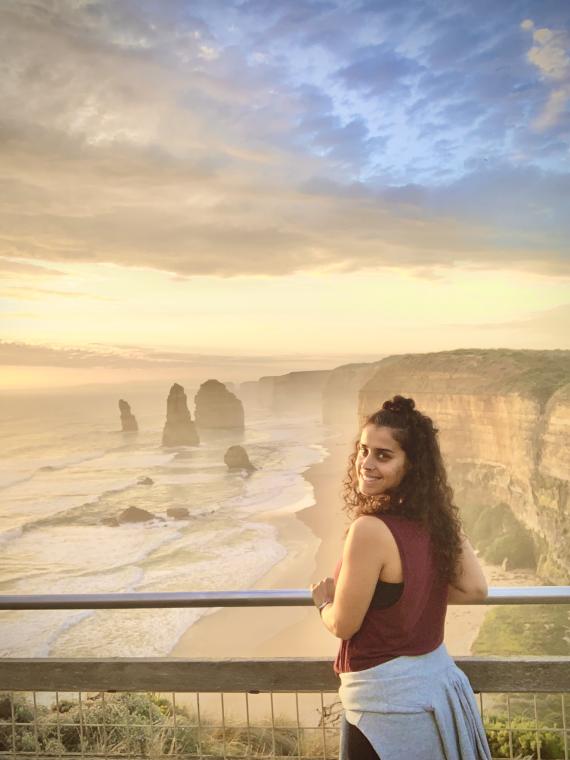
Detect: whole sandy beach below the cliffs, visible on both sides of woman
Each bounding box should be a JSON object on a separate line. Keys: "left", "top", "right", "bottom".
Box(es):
{"left": 170, "top": 434, "right": 536, "bottom": 658}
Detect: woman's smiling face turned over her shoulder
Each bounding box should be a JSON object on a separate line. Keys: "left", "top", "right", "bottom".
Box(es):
{"left": 355, "top": 425, "right": 408, "bottom": 496}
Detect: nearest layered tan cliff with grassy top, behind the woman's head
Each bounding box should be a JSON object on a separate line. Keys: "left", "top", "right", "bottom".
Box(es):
{"left": 359, "top": 350, "right": 570, "bottom": 583}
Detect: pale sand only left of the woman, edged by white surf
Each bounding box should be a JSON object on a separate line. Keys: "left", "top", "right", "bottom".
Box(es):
{"left": 168, "top": 435, "right": 346, "bottom": 658}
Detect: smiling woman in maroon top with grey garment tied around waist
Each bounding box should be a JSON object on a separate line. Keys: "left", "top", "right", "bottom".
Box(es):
{"left": 311, "top": 396, "right": 491, "bottom": 760}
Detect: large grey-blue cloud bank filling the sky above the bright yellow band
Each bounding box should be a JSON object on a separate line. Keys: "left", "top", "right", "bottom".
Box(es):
{"left": 0, "top": 0, "right": 568, "bottom": 276}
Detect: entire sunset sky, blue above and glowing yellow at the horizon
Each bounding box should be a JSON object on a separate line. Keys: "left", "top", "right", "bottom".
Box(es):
{"left": 0, "top": 0, "right": 570, "bottom": 388}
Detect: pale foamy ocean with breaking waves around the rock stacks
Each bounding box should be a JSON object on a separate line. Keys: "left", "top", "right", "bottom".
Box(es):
{"left": 0, "top": 386, "right": 327, "bottom": 657}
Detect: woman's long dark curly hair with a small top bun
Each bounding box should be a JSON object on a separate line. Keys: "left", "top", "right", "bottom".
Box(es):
{"left": 343, "top": 396, "right": 461, "bottom": 582}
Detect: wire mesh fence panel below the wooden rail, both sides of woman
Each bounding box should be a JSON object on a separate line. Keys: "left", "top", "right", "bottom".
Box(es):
{"left": 0, "top": 692, "right": 570, "bottom": 760}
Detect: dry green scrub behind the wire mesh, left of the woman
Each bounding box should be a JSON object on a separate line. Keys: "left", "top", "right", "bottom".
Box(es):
{"left": 0, "top": 693, "right": 303, "bottom": 758}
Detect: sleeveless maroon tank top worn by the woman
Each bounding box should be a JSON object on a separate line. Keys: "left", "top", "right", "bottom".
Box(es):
{"left": 334, "top": 513, "right": 448, "bottom": 673}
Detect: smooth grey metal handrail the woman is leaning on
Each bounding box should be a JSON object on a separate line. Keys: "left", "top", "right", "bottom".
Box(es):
{"left": 0, "top": 586, "right": 570, "bottom": 610}
